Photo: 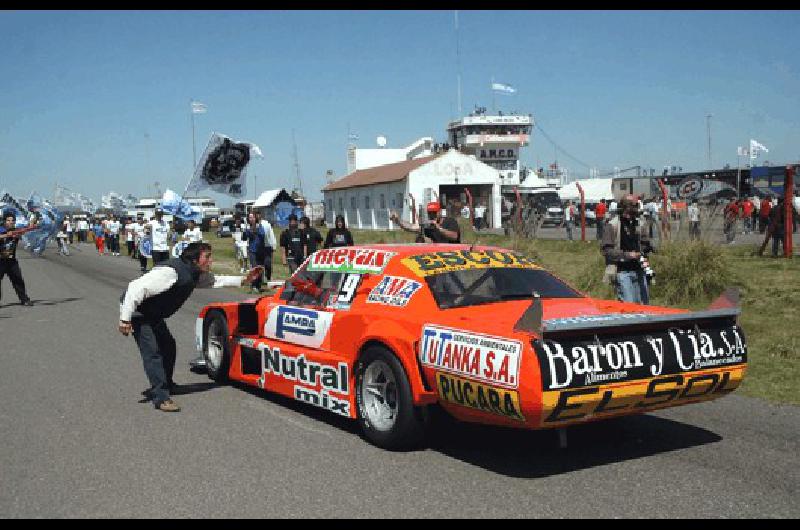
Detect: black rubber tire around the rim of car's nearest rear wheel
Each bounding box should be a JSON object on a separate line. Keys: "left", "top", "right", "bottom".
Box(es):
{"left": 356, "top": 346, "right": 427, "bottom": 451}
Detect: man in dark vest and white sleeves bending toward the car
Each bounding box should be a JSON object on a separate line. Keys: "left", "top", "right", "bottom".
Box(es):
{"left": 118, "top": 243, "right": 261, "bottom": 412}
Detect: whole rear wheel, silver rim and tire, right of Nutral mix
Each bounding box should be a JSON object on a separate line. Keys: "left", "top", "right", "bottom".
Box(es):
{"left": 356, "top": 346, "right": 425, "bottom": 451}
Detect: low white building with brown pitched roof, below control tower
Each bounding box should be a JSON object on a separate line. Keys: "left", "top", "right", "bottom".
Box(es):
{"left": 322, "top": 149, "right": 504, "bottom": 230}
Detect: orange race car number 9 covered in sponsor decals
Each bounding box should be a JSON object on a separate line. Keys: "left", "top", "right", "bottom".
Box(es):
{"left": 196, "top": 244, "right": 747, "bottom": 449}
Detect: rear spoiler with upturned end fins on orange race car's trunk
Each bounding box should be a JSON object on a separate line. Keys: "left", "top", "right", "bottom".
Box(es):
{"left": 514, "top": 289, "right": 741, "bottom": 336}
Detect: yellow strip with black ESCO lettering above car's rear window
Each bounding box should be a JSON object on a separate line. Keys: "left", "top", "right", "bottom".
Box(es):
{"left": 402, "top": 250, "right": 541, "bottom": 277}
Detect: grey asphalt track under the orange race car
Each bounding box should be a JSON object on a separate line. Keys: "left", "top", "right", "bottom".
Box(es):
{"left": 0, "top": 245, "right": 800, "bottom": 518}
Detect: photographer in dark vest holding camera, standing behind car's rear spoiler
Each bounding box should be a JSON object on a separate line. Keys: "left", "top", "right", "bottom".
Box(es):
{"left": 602, "top": 195, "right": 655, "bottom": 305}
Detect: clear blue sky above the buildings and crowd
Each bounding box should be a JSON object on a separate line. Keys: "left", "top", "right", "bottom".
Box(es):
{"left": 0, "top": 11, "right": 800, "bottom": 203}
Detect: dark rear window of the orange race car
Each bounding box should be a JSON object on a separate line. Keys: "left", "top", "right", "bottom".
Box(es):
{"left": 426, "top": 267, "right": 583, "bottom": 309}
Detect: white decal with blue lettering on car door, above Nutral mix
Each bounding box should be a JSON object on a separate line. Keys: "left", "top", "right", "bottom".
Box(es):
{"left": 264, "top": 305, "right": 333, "bottom": 348}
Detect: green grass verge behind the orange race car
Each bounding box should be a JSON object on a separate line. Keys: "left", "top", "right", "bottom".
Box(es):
{"left": 206, "top": 221, "right": 800, "bottom": 405}
